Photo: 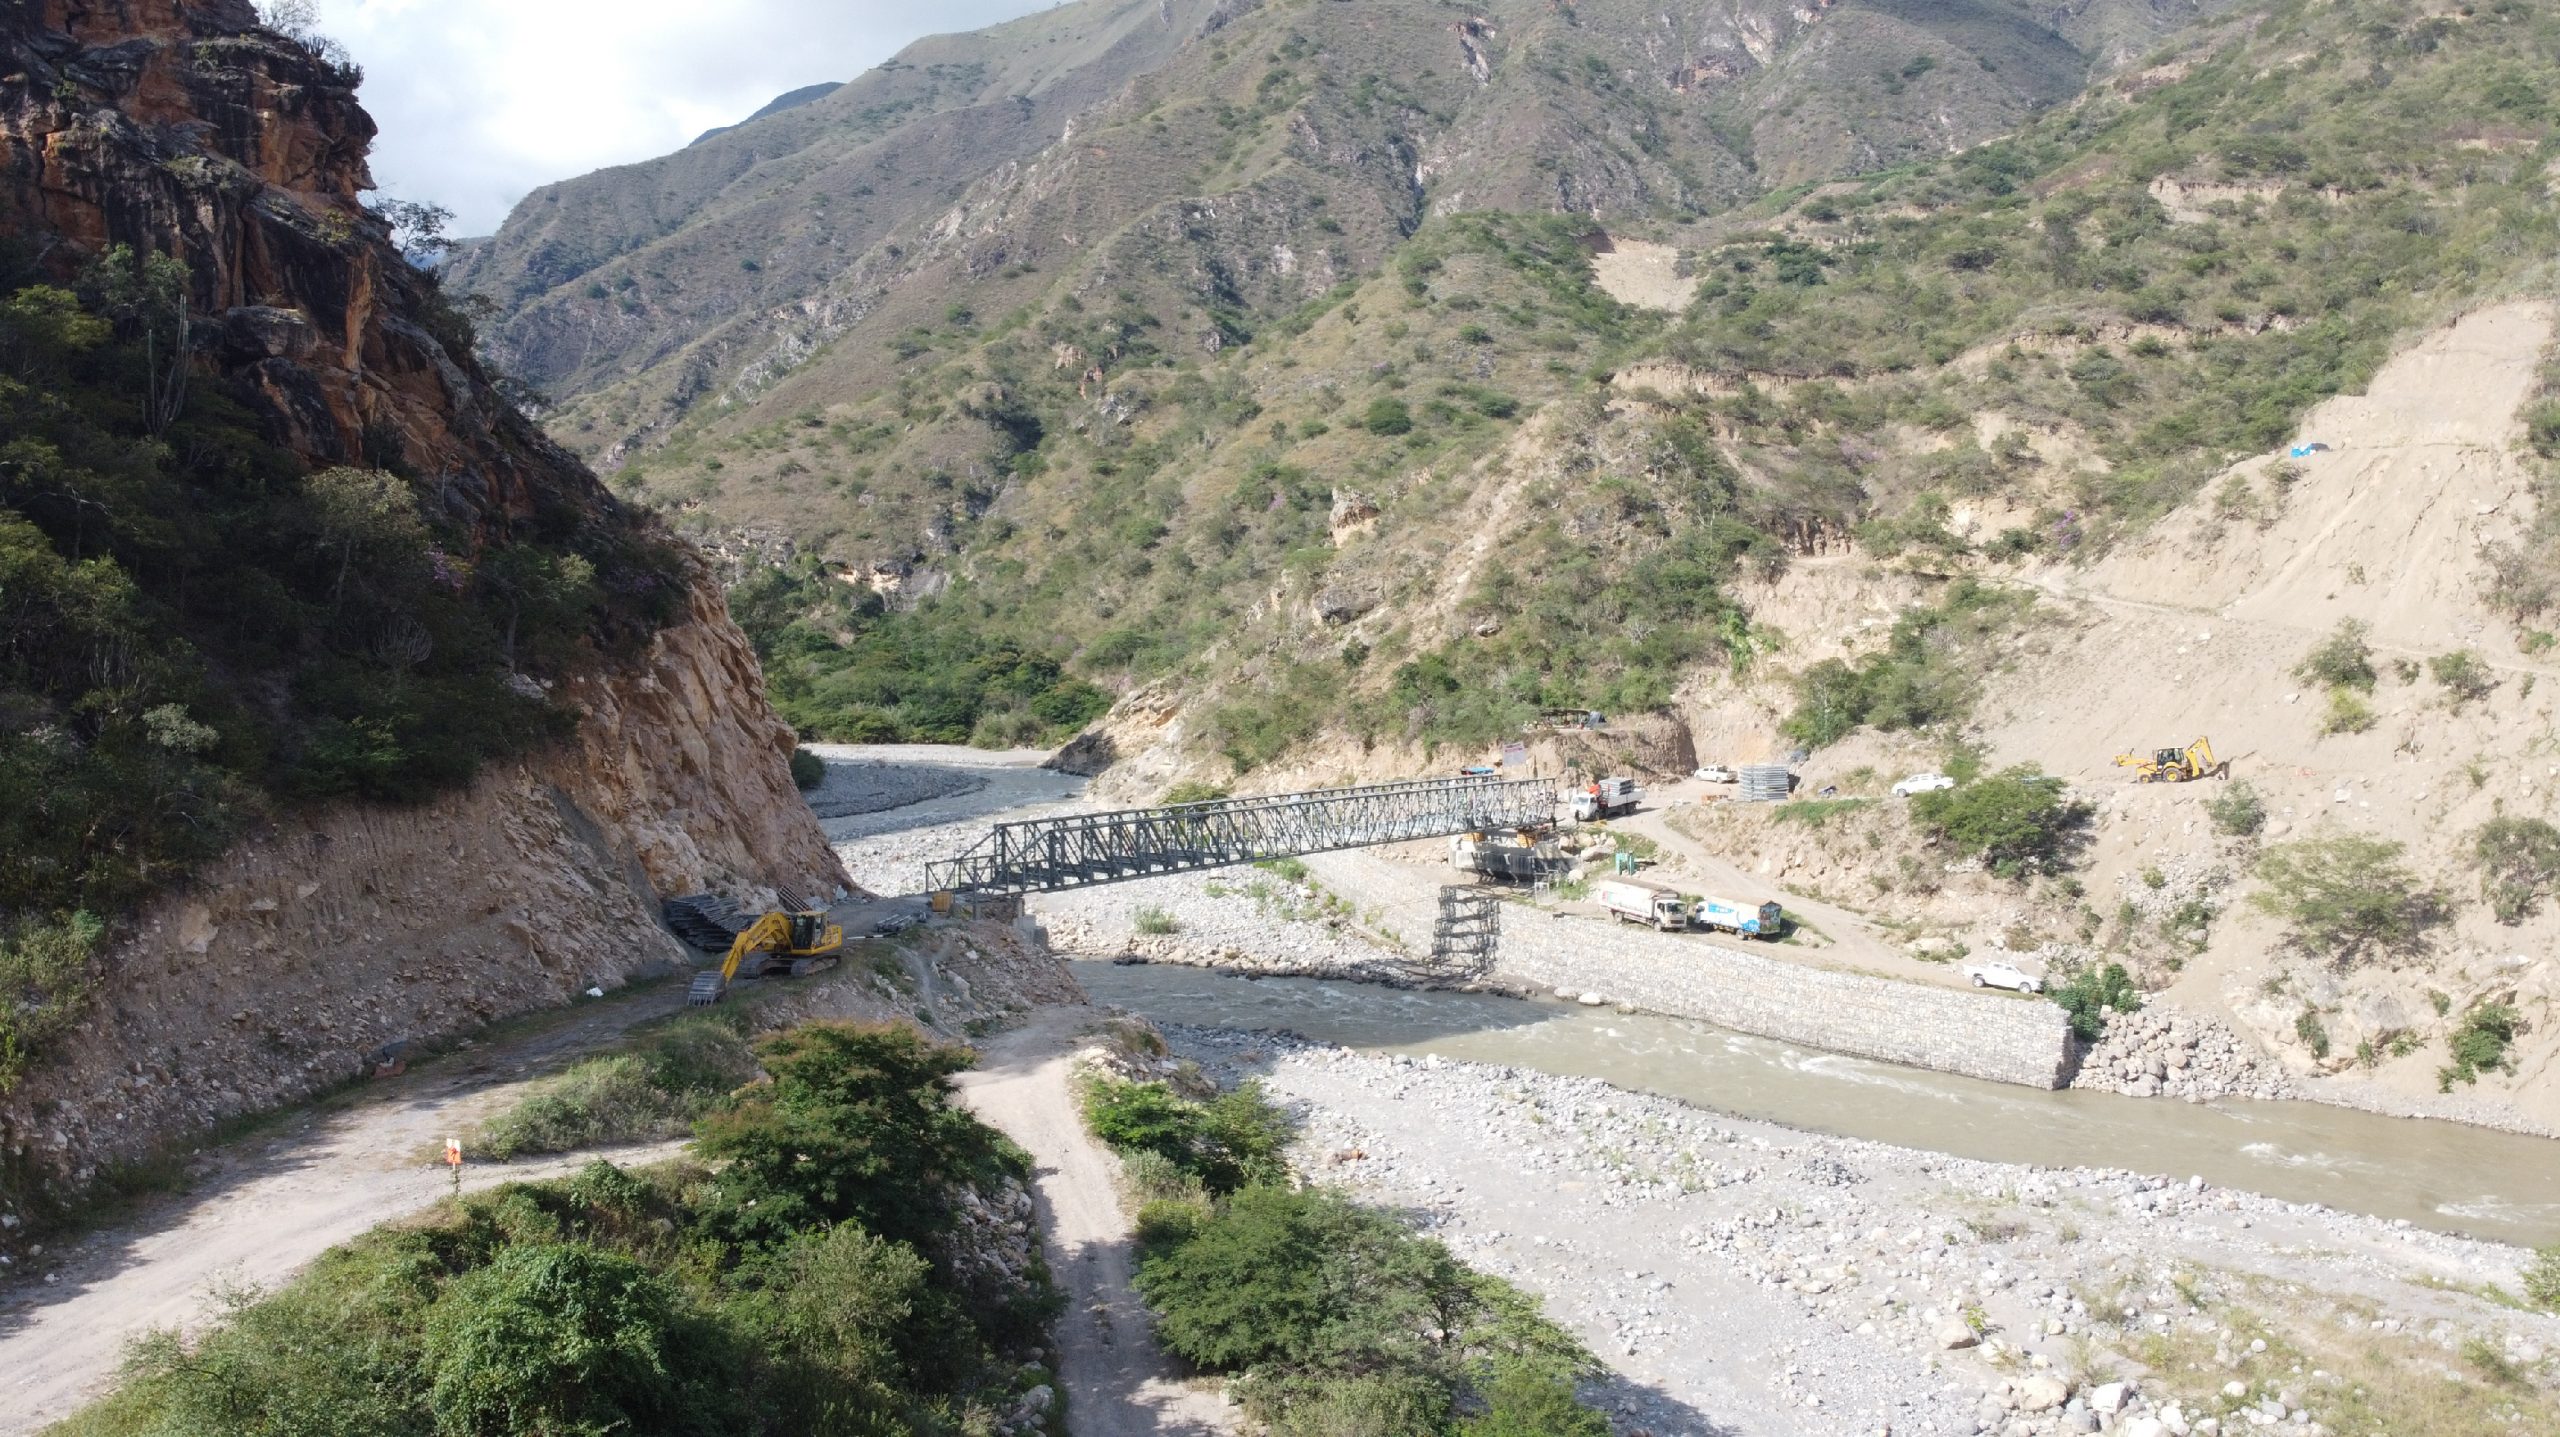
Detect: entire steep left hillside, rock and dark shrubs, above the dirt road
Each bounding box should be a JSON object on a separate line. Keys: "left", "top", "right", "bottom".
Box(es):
{"left": 0, "top": 0, "right": 842, "bottom": 1209}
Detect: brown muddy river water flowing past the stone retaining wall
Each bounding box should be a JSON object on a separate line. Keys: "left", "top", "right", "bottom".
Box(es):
{"left": 1075, "top": 963, "right": 2560, "bottom": 1245}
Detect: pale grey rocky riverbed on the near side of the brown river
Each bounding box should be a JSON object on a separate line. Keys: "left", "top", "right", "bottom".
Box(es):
{"left": 1167, "top": 1027, "right": 2560, "bottom": 1437}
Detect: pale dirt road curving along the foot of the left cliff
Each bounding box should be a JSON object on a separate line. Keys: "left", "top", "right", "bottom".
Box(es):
{"left": 0, "top": 986, "right": 684, "bottom": 1437}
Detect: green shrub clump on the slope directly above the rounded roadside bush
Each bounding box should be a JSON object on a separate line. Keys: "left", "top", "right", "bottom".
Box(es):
{"left": 1782, "top": 579, "right": 2033, "bottom": 748}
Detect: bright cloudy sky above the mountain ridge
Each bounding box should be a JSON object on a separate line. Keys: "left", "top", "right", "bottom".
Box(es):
{"left": 317, "top": 0, "right": 1052, "bottom": 236}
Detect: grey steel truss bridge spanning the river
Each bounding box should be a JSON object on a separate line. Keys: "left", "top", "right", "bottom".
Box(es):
{"left": 924, "top": 776, "right": 1556, "bottom": 894}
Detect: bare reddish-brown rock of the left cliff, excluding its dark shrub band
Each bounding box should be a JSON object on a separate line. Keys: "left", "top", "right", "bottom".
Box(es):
{"left": 0, "top": 0, "right": 845, "bottom": 1183}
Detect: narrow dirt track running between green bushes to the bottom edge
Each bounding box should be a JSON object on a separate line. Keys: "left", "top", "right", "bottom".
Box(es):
{"left": 960, "top": 1007, "right": 1234, "bottom": 1437}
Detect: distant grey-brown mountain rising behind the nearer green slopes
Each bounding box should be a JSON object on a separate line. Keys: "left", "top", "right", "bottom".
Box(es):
{"left": 456, "top": 0, "right": 2189, "bottom": 459}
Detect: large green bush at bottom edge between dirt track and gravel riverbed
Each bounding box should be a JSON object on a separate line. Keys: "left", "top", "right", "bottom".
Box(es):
{"left": 1137, "top": 1186, "right": 1592, "bottom": 1437}
